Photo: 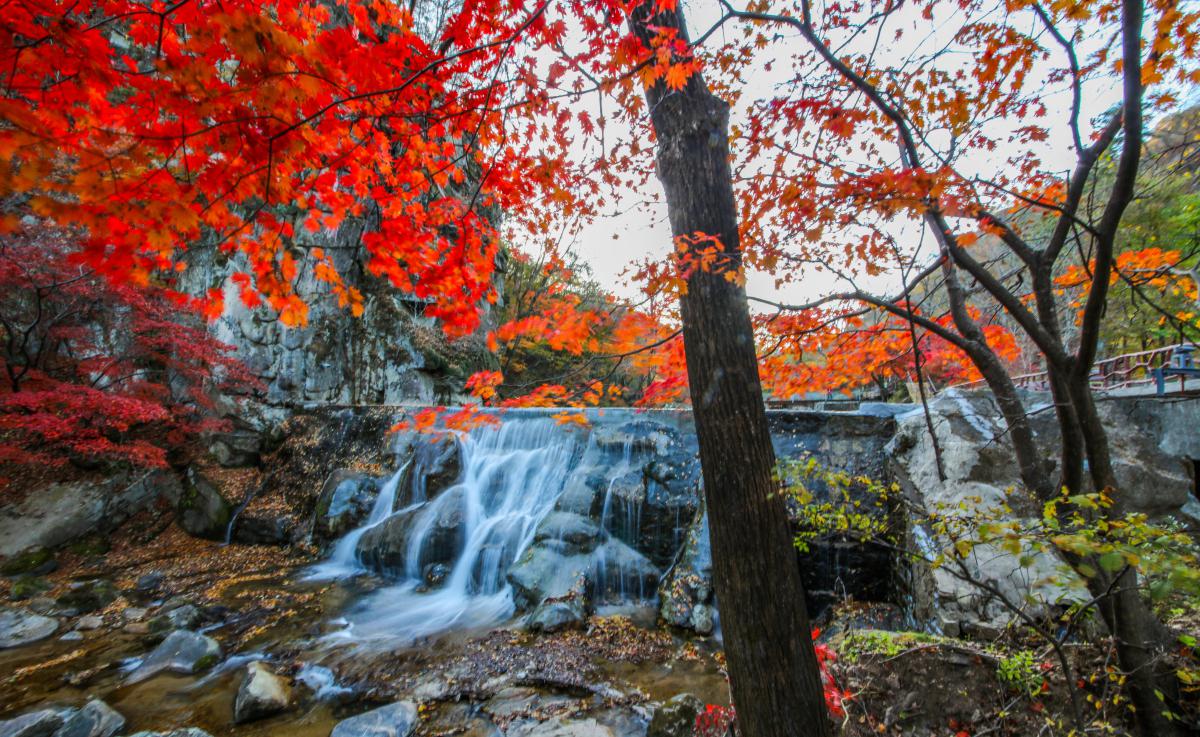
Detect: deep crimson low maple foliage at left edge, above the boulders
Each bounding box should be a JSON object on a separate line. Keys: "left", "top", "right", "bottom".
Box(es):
{"left": 0, "top": 233, "right": 257, "bottom": 480}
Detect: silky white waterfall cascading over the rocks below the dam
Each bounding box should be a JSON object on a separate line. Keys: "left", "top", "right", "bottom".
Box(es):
{"left": 320, "top": 418, "right": 582, "bottom": 645}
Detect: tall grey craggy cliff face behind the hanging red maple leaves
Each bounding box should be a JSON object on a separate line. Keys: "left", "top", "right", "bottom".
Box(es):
{"left": 180, "top": 216, "right": 492, "bottom": 424}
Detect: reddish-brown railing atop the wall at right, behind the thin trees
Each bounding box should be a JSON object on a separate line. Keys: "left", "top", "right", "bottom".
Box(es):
{"left": 954, "top": 343, "right": 1200, "bottom": 395}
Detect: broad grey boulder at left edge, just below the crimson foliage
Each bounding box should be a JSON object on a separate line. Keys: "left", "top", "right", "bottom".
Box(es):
{"left": 0, "top": 471, "right": 179, "bottom": 557}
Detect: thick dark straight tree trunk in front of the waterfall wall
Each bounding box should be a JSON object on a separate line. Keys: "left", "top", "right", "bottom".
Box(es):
{"left": 630, "top": 4, "right": 832, "bottom": 737}
